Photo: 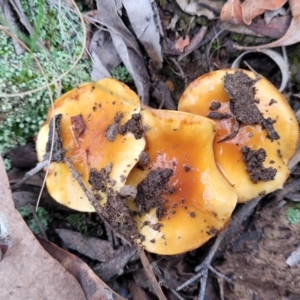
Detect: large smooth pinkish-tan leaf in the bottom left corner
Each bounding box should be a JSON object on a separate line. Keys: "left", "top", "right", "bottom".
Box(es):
{"left": 0, "top": 157, "right": 86, "bottom": 300}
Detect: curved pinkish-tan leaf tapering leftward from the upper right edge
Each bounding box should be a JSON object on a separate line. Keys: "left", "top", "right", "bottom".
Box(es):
{"left": 234, "top": 18, "right": 300, "bottom": 50}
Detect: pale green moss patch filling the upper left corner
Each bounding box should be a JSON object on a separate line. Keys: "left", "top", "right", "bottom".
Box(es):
{"left": 0, "top": 0, "right": 91, "bottom": 166}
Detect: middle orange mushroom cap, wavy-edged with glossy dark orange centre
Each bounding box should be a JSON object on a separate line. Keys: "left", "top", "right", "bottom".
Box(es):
{"left": 126, "top": 110, "right": 237, "bottom": 255}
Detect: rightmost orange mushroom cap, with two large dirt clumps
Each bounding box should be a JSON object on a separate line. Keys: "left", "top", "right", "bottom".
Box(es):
{"left": 178, "top": 69, "right": 299, "bottom": 202}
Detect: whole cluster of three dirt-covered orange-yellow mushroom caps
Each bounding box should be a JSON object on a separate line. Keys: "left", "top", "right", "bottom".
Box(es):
{"left": 36, "top": 70, "right": 298, "bottom": 255}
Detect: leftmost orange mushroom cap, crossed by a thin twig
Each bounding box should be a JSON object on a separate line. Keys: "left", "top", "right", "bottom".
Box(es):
{"left": 36, "top": 78, "right": 145, "bottom": 212}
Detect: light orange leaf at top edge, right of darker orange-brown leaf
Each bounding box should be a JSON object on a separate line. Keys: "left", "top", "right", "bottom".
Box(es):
{"left": 241, "top": 0, "right": 287, "bottom": 25}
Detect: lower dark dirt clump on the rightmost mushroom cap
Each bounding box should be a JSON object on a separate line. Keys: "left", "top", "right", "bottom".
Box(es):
{"left": 241, "top": 146, "right": 277, "bottom": 183}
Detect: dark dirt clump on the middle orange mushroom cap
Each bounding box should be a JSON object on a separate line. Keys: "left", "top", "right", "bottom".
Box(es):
{"left": 135, "top": 168, "right": 173, "bottom": 220}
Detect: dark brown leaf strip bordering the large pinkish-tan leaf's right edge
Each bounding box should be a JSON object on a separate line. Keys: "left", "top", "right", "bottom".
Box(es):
{"left": 39, "top": 239, "right": 125, "bottom": 300}
